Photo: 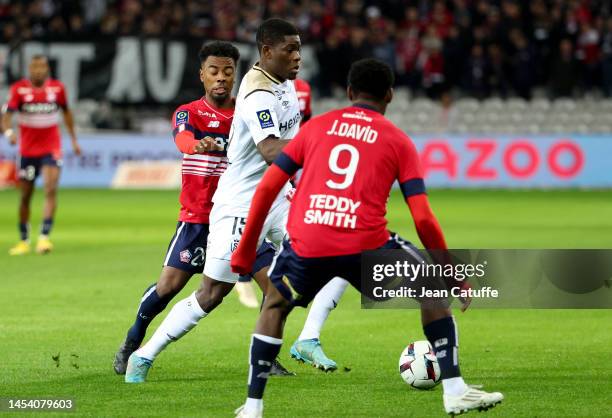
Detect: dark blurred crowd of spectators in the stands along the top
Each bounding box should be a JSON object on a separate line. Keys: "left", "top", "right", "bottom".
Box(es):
{"left": 0, "top": 0, "right": 612, "bottom": 98}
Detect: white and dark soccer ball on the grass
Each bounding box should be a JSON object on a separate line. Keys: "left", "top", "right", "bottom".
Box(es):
{"left": 399, "top": 341, "right": 440, "bottom": 389}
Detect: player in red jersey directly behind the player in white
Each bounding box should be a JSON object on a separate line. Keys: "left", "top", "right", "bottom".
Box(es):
{"left": 113, "top": 42, "right": 274, "bottom": 374}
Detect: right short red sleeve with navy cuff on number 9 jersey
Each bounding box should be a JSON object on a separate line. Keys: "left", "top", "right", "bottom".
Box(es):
{"left": 397, "top": 133, "right": 425, "bottom": 198}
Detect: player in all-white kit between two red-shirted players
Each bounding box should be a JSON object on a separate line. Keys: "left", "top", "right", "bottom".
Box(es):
{"left": 125, "top": 19, "right": 344, "bottom": 383}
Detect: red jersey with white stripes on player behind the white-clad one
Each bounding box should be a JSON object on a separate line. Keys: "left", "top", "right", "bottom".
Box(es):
{"left": 172, "top": 98, "right": 234, "bottom": 223}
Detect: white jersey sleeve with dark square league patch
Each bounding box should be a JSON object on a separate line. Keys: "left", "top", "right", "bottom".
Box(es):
{"left": 240, "top": 90, "right": 280, "bottom": 145}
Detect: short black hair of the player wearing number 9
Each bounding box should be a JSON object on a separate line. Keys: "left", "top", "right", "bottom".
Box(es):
{"left": 348, "top": 58, "right": 395, "bottom": 100}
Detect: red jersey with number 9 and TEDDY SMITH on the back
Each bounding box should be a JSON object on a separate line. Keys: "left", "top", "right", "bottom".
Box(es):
{"left": 275, "top": 106, "right": 425, "bottom": 257}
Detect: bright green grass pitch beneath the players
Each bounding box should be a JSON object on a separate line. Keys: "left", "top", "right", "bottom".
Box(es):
{"left": 0, "top": 190, "right": 612, "bottom": 417}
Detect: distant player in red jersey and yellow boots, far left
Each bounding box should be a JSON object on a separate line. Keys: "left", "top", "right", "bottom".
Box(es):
{"left": 1, "top": 55, "right": 81, "bottom": 255}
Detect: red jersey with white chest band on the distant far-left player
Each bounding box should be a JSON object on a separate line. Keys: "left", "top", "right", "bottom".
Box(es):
{"left": 6, "top": 78, "right": 68, "bottom": 159}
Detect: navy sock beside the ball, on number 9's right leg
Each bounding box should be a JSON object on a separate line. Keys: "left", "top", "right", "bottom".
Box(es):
{"left": 423, "top": 316, "right": 467, "bottom": 395}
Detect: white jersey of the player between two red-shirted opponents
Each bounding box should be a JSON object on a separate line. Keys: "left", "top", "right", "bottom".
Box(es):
{"left": 213, "top": 65, "right": 300, "bottom": 217}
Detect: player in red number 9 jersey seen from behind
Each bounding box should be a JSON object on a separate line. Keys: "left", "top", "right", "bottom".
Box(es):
{"left": 231, "top": 59, "right": 503, "bottom": 418}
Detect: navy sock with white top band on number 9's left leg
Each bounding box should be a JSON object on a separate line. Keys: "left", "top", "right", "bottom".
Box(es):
{"left": 248, "top": 334, "right": 283, "bottom": 399}
